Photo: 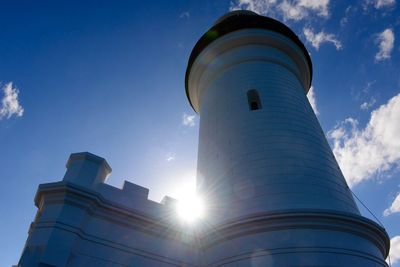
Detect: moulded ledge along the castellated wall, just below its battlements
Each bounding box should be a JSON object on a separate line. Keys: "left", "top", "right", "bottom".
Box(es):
{"left": 35, "top": 182, "right": 200, "bottom": 244}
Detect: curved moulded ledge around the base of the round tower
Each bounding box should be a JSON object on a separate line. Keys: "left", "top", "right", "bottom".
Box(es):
{"left": 201, "top": 209, "right": 390, "bottom": 258}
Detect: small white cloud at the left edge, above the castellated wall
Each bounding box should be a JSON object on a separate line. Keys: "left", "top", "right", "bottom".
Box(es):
{"left": 0, "top": 82, "right": 24, "bottom": 120}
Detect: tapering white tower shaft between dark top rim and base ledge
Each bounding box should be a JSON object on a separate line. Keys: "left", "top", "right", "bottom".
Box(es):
{"left": 189, "top": 29, "right": 359, "bottom": 221}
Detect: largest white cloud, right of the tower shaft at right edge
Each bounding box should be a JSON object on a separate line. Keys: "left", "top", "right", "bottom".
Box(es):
{"left": 328, "top": 94, "right": 400, "bottom": 186}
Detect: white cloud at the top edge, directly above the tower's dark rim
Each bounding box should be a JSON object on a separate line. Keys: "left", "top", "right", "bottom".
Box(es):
{"left": 230, "top": 0, "right": 329, "bottom": 21}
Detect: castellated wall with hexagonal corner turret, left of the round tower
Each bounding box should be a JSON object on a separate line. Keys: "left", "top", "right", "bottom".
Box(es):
{"left": 19, "top": 153, "right": 199, "bottom": 267}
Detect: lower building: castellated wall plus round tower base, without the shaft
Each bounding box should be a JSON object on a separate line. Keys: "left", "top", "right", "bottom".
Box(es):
{"left": 17, "top": 153, "right": 386, "bottom": 267}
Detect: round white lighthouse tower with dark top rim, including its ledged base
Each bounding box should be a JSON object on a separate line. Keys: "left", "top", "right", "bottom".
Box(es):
{"left": 186, "top": 11, "right": 389, "bottom": 267}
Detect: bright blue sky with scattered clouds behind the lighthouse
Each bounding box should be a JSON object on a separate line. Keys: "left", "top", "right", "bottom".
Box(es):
{"left": 0, "top": 0, "right": 400, "bottom": 267}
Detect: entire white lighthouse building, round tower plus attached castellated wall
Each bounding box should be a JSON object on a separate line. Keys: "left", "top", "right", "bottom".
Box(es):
{"left": 17, "top": 11, "right": 390, "bottom": 267}
